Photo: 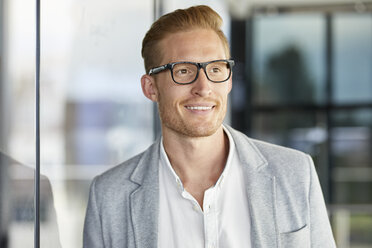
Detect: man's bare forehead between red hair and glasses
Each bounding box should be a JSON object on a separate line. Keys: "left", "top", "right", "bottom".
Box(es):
{"left": 160, "top": 29, "right": 226, "bottom": 64}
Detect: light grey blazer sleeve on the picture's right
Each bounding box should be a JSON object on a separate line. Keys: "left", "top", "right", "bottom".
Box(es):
{"left": 308, "top": 155, "right": 336, "bottom": 248}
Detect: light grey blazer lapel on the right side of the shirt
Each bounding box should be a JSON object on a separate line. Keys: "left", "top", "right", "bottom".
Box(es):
{"left": 228, "top": 127, "right": 278, "bottom": 248}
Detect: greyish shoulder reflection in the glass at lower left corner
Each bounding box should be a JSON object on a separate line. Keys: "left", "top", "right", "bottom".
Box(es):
{"left": 0, "top": 151, "right": 61, "bottom": 248}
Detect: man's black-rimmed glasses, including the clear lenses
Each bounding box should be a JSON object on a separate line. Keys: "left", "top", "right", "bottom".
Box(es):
{"left": 149, "top": 59, "right": 235, "bottom": 84}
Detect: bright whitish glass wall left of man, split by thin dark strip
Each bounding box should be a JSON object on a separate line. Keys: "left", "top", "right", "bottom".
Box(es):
{"left": 0, "top": 0, "right": 153, "bottom": 248}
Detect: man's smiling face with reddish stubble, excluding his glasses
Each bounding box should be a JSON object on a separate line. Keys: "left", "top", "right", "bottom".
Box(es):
{"left": 150, "top": 29, "right": 232, "bottom": 137}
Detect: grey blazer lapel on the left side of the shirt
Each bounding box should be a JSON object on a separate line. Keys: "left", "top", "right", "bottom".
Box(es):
{"left": 130, "top": 140, "right": 159, "bottom": 248}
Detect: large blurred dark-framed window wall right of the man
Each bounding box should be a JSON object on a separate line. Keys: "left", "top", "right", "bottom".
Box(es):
{"left": 231, "top": 6, "right": 372, "bottom": 247}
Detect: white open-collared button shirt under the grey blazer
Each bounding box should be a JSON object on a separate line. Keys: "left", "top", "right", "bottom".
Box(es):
{"left": 158, "top": 128, "right": 251, "bottom": 248}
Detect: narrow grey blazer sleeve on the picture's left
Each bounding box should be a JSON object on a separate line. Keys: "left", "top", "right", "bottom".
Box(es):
{"left": 83, "top": 178, "right": 105, "bottom": 248}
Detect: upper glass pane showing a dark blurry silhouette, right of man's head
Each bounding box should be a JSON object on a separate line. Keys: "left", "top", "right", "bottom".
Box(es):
{"left": 253, "top": 14, "right": 325, "bottom": 104}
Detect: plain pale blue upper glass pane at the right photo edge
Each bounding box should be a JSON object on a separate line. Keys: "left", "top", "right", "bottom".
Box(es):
{"left": 333, "top": 14, "right": 372, "bottom": 103}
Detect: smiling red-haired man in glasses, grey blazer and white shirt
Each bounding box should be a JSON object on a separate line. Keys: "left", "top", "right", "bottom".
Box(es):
{"left": 84, "top": 6, "right": 335, "bottom": 248}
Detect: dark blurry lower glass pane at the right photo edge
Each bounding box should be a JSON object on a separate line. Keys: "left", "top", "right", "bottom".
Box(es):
{"left": 331, "top": 109, "right": 372, "bottom": 203}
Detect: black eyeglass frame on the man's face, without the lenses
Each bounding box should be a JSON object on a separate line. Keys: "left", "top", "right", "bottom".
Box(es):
{"left": 149, "top": 59, "right": 235, "bottom": 85}
